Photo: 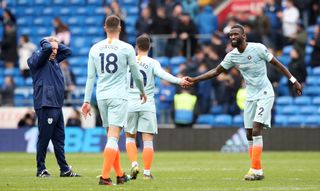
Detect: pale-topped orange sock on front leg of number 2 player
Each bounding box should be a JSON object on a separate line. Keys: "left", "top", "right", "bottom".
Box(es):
{"left": 251, "top": 136, "right": 263, "bottom": 170}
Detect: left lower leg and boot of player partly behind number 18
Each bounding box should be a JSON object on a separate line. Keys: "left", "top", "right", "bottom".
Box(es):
{"left": 126, "top": 133, "right": 140, "bottom": 180}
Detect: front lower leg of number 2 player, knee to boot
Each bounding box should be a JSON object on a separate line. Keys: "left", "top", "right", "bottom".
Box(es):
{"left": 244, "top": 122, "right": 264, "bottom": 180}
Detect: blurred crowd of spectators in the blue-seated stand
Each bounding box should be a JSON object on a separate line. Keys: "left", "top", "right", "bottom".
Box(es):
{"left": 0, "top": 0, "right": 320, "bottom": 127}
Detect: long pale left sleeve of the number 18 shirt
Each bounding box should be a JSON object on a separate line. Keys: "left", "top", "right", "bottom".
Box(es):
{"left": 84, "top": 50, "right": 97, "bottom": 103}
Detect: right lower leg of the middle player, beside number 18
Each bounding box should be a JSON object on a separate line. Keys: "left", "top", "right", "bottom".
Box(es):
{"left": 142, "top": 133, "right": 154, "bottom": 180}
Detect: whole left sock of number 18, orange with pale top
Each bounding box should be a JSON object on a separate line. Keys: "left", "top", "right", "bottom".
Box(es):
{"left": 102, "top": 137, "right": 119, "bottom": 179}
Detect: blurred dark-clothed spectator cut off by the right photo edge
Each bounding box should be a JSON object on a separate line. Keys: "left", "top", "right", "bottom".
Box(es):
{"left": 309, "top": 19, "right": 320, "bottom": 67}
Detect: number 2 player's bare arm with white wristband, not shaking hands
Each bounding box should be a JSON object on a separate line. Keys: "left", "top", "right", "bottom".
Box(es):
{"left": 270, "top": 57, "right": 302, "bottom": 96}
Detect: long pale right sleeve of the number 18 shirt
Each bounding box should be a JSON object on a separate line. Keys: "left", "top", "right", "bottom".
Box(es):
{"left": 128, "top": 47, "right": 144, "bottom": 93}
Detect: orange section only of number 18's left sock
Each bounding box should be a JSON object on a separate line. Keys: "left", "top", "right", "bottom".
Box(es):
{"left": 102, "top": 147, "right": 117, "bottom": 179}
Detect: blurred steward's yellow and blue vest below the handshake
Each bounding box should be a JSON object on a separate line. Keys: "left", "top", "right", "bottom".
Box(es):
{"left": 174, "top": 89, "right": 197, "bottom": 127}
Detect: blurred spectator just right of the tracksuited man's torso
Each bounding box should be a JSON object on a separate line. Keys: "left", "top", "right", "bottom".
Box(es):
{"left": 60, "top": 60, "right": 76, "bottom": 105}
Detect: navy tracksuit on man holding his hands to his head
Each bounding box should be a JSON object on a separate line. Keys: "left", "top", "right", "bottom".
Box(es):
{"left": 28, "top": 39, "right": 71, "bottom": 174}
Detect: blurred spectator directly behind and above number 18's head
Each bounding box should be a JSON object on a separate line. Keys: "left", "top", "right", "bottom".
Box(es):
{"left": 103, "top": 0, "right": 128, "bottom": 42}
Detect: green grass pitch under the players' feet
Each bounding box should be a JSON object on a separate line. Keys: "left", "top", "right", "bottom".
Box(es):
{"left": 0, "top": 152, "right": 320, "bottom": 191}
